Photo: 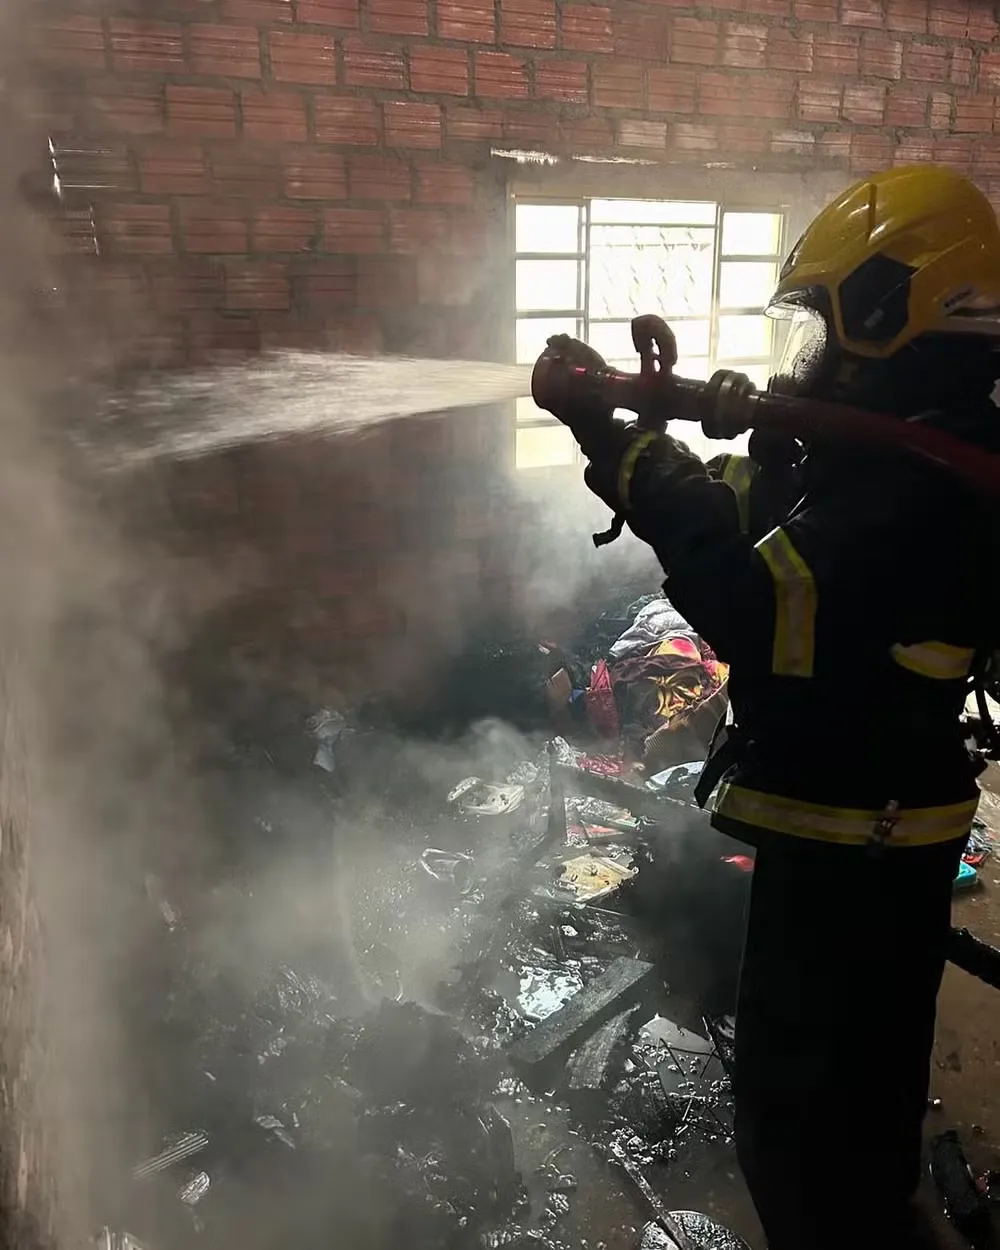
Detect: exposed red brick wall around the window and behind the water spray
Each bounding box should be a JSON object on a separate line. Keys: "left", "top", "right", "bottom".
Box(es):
{"left": 27, "top": 0, "right": 1000, "bottom": 705}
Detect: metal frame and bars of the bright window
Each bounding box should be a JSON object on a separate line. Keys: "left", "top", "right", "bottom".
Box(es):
{"left": 509, "top": 195, "right": 794, "bottom": 473}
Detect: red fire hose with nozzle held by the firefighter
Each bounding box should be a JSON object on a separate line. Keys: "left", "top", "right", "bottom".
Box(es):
{"left": 531, "top": 316, "right": 1000, "bottom": 510}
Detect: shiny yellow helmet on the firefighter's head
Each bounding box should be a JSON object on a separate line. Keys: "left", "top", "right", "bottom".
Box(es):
{"left": 769, "top": 165, "right": 1000, "bottom": 360}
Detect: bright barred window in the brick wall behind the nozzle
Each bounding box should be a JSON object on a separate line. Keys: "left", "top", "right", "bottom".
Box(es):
{"left": 514, "top": 199, "right": 785, "bottom": 469}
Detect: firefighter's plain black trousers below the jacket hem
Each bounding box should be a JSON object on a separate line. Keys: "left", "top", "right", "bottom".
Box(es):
{"left": 734, "top": 838, "right": 964, "bottom": 1250}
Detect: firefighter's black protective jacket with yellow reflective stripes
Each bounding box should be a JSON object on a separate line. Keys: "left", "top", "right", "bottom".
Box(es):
{"left": 619, "top": 415, "right": 1000, "bottom": 846}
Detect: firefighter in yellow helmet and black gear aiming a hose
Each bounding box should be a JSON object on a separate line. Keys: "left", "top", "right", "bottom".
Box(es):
{"left": 556, "top": 166, "right": 1000, "bottom": 1250}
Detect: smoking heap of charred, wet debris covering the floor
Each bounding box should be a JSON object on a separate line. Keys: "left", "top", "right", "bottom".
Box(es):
{"left": 99, "top": 590, "right": 753, "bottom": 1250}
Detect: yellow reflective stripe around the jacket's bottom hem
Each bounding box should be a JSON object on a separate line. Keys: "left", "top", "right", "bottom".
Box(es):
{"left": 714, "top": 783, "right": 979, "bottom": 846}
